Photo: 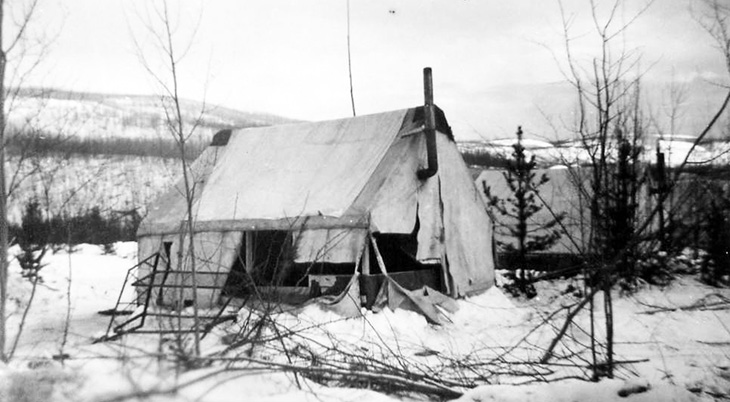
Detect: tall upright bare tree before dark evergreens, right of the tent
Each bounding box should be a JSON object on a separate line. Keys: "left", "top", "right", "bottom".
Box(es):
{"left": 542, "top": 0, "right": 651, "bottom": 378}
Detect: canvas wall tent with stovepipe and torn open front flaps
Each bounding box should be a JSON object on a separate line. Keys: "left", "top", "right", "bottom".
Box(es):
{"left": 137, "top": 103, "right": 494, "bottom": 320}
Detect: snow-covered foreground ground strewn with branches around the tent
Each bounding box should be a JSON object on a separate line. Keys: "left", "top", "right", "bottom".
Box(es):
{"left": 0, "top": 243, "right": 730, "bottom": 401}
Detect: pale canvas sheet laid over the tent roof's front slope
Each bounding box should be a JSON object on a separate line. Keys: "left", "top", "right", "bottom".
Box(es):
{"left": 197, "top": 110, "right": 407, "bottom": 221}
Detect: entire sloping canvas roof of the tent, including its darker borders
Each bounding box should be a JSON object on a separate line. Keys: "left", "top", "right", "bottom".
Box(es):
{"left": 138, "top": 107, "right": 453, "bottom": 235}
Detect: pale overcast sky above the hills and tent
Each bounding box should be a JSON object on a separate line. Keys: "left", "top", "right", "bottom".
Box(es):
{"left": 21, "top": 0, "right": 725, "bottom": 139}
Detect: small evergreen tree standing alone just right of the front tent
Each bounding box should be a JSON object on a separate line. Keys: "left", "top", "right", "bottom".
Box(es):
{"left": 483, "top": 127, "right": 564, "bottom": 297}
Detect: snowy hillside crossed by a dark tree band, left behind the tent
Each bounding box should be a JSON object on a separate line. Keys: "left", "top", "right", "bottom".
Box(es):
{"left": 6, "top": 88, "right": 302, "bottom": 223}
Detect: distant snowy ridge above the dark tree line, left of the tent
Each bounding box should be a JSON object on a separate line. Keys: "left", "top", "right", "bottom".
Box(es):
{"left": 8, "top": 88, "right": 295, "bottom": 141}
